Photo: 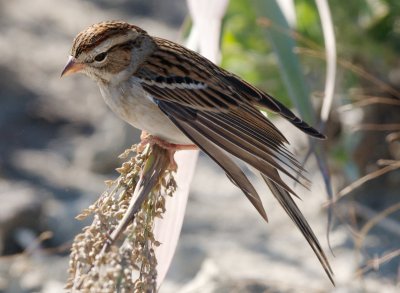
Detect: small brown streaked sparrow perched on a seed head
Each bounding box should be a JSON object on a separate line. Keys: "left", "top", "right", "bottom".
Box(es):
{"left": 61, "top": 21, "right": 334, "bottom": 284}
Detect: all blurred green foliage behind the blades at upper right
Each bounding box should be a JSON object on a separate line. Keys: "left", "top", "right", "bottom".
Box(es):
{"left": 222, "top": 0, "right": 400, "bottom": 171}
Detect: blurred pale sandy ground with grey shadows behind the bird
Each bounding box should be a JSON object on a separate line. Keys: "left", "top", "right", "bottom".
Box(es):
{"left": 0, "top": 0, "right": 399, "bottom": 293}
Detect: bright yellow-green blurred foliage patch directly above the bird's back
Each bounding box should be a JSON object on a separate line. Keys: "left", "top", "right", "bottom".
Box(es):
{"left": 222, "top": 0, "right": 290, "bottom": 104}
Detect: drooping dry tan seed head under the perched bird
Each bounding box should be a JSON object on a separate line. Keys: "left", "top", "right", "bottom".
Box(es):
{"left": 66, "top": 145, "right": 176, "bottom": 292}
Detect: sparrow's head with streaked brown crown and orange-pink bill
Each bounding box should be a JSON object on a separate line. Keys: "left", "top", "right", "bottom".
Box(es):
{"left": 61, "top": 21, "right": 155, "bottom": 83}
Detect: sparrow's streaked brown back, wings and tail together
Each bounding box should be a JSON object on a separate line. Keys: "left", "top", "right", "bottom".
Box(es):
{"left": 135, "top": 40, "right": 332, "bottom": 278}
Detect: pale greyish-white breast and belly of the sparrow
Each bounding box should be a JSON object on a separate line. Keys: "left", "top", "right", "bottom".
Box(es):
{"left": 100, "top": 80, "right": 193, "bottom": 144}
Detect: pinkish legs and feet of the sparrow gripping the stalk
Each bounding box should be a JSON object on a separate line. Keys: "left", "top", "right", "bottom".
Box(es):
{"left": 137, "top": 130, "right": 199, "bottom": 171}
